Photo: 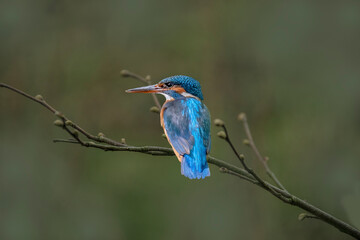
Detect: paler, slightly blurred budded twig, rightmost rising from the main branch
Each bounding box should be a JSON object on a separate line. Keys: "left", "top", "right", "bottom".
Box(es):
{"left": 238, "top": 113, "right": 287, "bottom": 191}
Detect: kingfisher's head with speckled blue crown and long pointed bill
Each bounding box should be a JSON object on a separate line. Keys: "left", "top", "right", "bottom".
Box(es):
{"left": 126, "top": 75, "right": 204, "bottom": 100}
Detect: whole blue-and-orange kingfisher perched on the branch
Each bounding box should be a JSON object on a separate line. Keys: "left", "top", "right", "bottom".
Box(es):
{"left": 126, "top": 75, "right": 211, "bottom": 179}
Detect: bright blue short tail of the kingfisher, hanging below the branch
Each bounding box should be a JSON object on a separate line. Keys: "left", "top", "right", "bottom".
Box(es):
{"left": 181, "top": 155, "right": 210, "bottom": 179}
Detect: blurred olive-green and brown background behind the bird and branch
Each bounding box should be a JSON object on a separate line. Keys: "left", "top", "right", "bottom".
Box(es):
{"left": 0, "top": 0, "right": 360, "bottom": 239}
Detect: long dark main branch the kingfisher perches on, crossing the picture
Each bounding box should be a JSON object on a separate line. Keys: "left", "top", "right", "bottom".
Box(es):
{"left": 0, "top": 83, "right": 360, "bottom": 239}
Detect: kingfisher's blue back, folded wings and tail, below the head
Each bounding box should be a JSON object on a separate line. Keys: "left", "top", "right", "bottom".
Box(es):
{"left": 163, "top": 98, "right": 210, "bottom": 179}
